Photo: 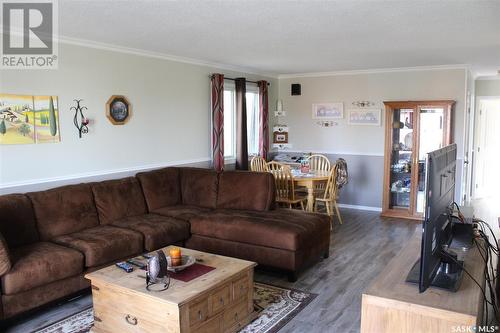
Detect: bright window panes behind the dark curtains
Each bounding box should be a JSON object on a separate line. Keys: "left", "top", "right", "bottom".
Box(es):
{"left": 224, "top": 82, "right": 260, "bottom": 159}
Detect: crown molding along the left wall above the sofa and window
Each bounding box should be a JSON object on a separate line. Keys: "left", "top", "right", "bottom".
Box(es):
{"left": 58, "top": 35, "right": 278, "bottom": 79}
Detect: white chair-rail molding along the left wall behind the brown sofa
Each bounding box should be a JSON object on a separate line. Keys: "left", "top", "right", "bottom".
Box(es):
{"left": 0, "top": 157, "right": 210, "bottom": 194}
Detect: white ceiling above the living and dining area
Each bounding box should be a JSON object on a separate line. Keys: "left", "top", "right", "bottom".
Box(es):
{"left": 59, "top": 0, "right": 500, "bottom": 75}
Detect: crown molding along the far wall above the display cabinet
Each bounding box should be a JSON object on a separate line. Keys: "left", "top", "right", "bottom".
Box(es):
{"left": 278, "top": 64, "right": 469, "bottom": 79}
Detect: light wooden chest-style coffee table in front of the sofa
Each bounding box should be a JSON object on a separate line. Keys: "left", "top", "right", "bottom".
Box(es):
{"left": 85, "top": 247, "right": 257, "bottom": 333}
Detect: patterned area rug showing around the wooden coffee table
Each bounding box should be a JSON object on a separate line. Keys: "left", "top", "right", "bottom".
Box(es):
{"left": 37, "top": 282, "right": 317, "bottom": 333}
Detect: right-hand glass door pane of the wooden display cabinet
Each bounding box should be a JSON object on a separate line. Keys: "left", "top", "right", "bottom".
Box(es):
{"left": 416, "top": 106, "right": 447, "bottom": 214}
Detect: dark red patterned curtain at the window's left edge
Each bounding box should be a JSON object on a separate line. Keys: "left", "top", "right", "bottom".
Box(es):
{"left": 212, "top": 74, "right": 224, "bottom": 171}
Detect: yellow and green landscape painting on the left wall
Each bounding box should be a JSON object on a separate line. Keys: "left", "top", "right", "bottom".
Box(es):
{"left": 0, "top": 94, "right": 61, "bottom": 145}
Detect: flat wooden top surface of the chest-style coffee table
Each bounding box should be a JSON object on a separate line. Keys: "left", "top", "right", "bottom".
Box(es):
{"left": 85, "top": 246, "right": 257, "bottom": 306}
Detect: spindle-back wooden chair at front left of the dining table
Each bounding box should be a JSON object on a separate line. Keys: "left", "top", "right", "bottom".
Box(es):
{"left": 271, "top": 167, "right": 307, "bottom": 210}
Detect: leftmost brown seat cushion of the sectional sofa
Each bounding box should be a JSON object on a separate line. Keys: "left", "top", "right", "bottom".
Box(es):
{"left": 2, "top": 242, "right": 83, "bottom": 295}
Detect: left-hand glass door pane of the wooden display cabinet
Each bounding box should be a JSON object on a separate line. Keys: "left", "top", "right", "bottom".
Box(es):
{"left": 389, "top": 108, "right": 416, "bottom": 209}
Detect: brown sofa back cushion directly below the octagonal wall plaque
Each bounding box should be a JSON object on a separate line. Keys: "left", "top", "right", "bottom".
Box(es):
{"left": 92, "top": 177, "right": 146, "bottom": 224}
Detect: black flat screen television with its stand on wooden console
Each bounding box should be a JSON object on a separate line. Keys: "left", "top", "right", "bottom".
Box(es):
{"left": 407, "top": 144, "right": 466, "bottom": 292}
